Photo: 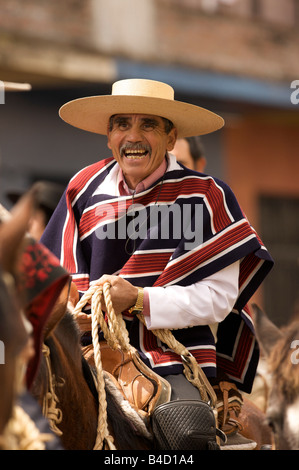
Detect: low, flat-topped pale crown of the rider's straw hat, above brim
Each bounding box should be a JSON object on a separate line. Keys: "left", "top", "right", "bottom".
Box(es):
{"left": 112, "top": 78, "right": 174, "bottom": 100}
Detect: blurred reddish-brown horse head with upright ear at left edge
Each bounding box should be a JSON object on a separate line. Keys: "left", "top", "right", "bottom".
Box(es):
{"left": 0, "top": 193, "right": 36, "bottom": 435}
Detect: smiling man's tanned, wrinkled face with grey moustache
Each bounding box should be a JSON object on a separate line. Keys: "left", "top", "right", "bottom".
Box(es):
{"left": 108, "top": 114, "right": 177, "bottom": 189}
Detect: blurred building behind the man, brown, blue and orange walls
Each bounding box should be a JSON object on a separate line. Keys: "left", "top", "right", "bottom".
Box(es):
{"left": 0, "top": 0, "right": 299, "bottom": 325}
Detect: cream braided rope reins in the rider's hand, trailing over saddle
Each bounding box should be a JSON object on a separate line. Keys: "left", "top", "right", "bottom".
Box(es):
{"left": 73, "top": 282, "right": 217, "bottom": 450}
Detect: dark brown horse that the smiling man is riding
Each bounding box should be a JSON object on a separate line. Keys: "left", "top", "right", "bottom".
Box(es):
{"left": 31, "top": 304, "right": 149, "bottom": 450}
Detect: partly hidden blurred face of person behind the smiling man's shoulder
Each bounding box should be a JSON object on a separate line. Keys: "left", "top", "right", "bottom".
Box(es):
{"left": 171, "top": 136, "right": 207, "bottom": 173}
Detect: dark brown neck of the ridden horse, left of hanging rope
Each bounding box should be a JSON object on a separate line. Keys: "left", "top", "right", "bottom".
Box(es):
{"left": 30, "top": 313, "right": 98, "bottom": 450}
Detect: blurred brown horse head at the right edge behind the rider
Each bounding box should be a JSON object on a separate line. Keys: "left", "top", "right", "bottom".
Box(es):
{"left": 253, "top": 305, "right": 299, "bottom": 450}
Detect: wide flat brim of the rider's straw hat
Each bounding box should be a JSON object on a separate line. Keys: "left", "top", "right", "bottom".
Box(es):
{"left": 59, "top": 95, "right": 224, "bottom": 137}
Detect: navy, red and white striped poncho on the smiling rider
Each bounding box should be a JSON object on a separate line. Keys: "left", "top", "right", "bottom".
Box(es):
{"left": 42, "top": 158, "right": 273, "bottom": 392}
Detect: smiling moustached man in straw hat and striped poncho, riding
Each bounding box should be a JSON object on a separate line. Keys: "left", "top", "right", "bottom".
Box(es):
{"left": 42, "top": 79, "right": 273, "bottom": 448}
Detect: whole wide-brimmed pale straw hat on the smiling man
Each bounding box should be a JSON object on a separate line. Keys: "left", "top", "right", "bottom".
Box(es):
{"left": 59, "top": 78, "right": 224, "bottom": 137}
